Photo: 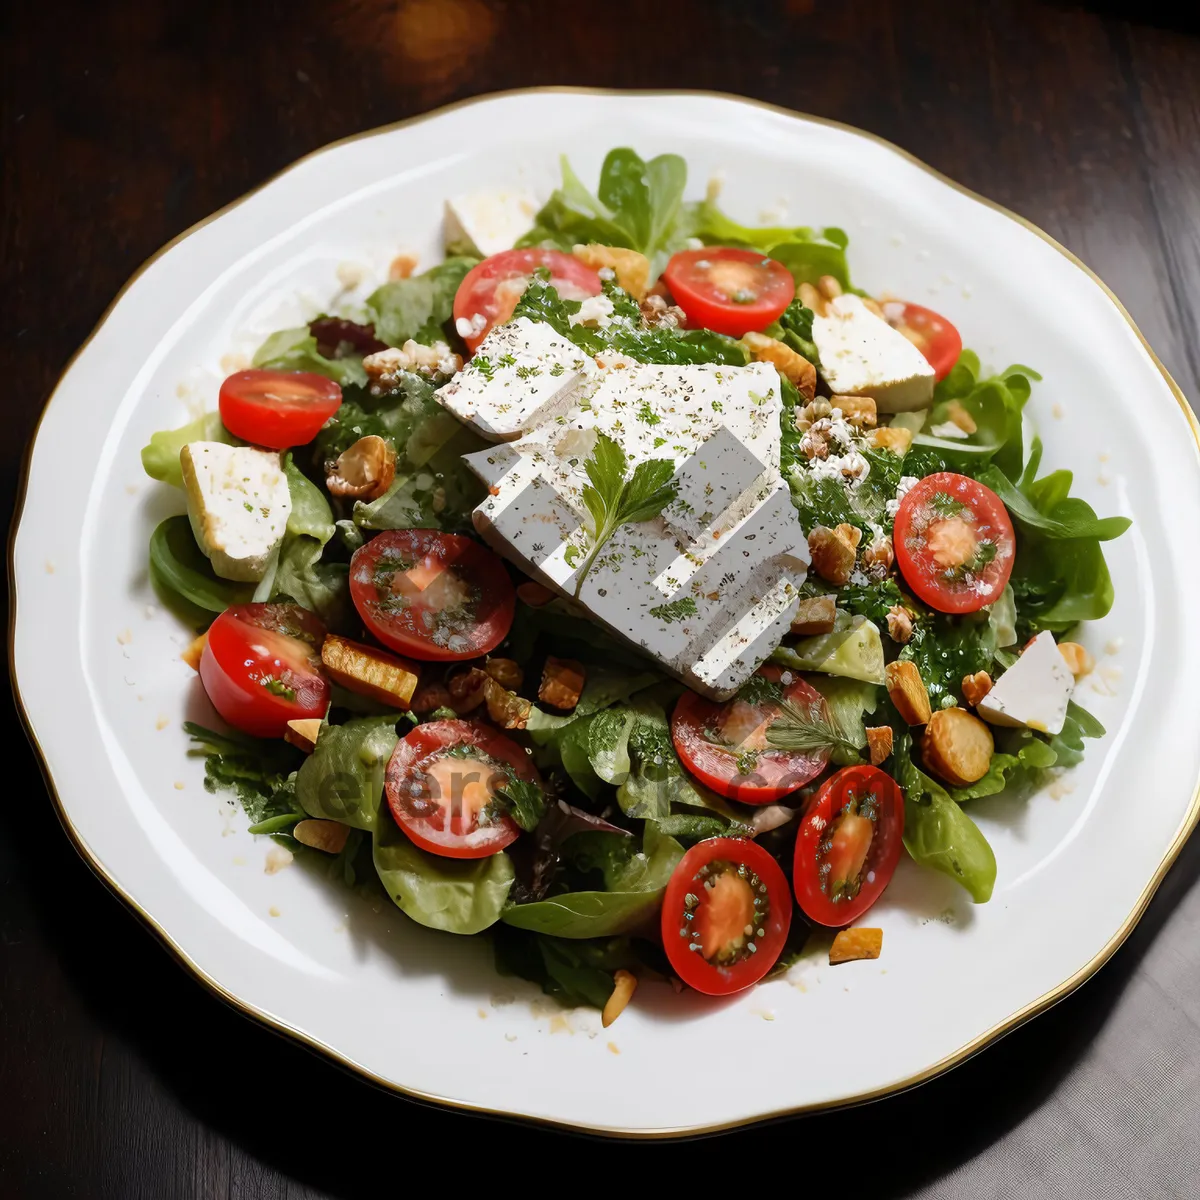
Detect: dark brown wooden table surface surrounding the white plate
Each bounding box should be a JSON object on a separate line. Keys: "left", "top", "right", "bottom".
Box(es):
{"left": 0, "top": 0, "right": 1200, "bottom": 1198}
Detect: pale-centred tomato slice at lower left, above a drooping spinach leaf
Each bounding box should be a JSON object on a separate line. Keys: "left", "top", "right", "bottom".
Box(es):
{"left": 384, "top": 721, "right": 541, "bottom": 858}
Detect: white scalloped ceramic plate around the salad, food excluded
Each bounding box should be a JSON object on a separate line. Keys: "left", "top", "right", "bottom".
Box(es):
{"left": 13, "top": 91, "right": 1200, "bottom": 1135}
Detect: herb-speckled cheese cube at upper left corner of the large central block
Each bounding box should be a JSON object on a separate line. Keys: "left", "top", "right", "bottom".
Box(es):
{"left": 438, "top": 317, "right": 600, "bottom": 442}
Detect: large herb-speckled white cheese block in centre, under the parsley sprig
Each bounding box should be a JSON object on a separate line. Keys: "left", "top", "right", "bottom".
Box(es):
{"left": 439, "top": 345, "right": 809, "bottom": 698}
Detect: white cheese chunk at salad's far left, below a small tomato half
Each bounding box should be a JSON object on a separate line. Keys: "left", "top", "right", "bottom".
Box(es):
{"left": 179, "top": 442, "right": 292, "bottom": 582}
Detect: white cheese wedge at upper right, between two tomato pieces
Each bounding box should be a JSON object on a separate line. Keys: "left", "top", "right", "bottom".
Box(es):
{"left": 812, "top": 293, "right": 935, "bottom": 413}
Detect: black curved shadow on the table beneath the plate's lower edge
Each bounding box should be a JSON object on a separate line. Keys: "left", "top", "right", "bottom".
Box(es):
{"left": 14, "top": 700, "right": 1200, "bottom": 1200}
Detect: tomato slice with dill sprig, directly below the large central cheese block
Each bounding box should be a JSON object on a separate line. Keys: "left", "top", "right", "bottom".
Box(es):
{"left": 671, "top": 666, "right": 829, "bottom": 804}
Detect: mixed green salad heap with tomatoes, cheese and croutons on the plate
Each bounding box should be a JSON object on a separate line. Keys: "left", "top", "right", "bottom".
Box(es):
{"left": 143, "top": 149, "right": 1128, "bottom": 1024}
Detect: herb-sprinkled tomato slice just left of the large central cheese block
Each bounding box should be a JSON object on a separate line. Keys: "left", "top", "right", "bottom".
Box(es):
{"left": 350, "top": 529, "right": 516, "bottom": 661}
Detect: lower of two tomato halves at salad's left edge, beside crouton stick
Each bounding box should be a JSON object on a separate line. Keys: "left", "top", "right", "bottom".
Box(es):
{"left": 200, "top": 604, "right": 329, "bottom": 738}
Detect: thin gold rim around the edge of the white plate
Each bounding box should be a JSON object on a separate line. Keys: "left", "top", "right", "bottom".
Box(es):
{"left": 8, "top": 88, "right": 1200, "bottom": 1140}
